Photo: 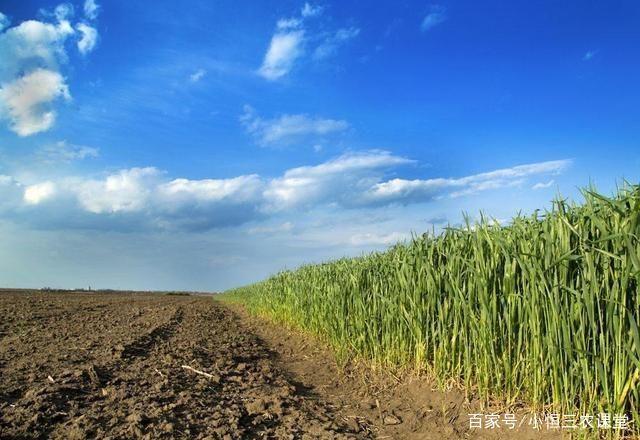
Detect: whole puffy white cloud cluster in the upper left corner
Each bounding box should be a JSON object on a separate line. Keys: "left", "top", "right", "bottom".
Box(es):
{"left": 0, "top": 3, "right": 97, "bottom": 136}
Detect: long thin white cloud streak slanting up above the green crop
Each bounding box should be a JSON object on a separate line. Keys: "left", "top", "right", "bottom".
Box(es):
{"left": 368, "top": 160, "right": 571, "bottom": 203}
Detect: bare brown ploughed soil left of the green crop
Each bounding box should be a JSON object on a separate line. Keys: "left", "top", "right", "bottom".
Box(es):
{"left": 0, "top": 291, "right": 559, "bottom": 440}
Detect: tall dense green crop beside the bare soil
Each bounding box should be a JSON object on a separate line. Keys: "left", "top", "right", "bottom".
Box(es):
{"left": 221, "top": 185, "right": 640, "bottom": 430}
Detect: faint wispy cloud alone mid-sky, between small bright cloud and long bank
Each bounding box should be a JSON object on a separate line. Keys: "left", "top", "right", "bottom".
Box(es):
{"left": 240, "top": 106, "right": 349, "bottom": 145}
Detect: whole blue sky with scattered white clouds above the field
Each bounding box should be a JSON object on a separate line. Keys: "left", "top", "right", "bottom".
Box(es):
{"left": 0, "top": 0, "right": 640, "bottom": 290}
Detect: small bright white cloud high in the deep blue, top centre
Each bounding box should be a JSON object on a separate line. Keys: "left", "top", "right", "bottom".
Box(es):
{"left": 258, "top": 30, "right": 304, "bottom": 81}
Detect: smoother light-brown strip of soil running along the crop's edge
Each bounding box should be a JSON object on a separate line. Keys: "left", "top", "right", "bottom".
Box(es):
{"left": 229, "top": 304, "right": 568, "bottom": 440}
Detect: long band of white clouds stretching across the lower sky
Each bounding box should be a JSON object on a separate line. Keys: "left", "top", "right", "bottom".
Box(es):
{"left": 0, "top": 150, "right": 570, "bottom": 232}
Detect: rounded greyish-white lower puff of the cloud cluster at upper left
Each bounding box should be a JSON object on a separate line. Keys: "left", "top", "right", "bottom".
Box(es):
{"left": 0, "top": 69, "right": 71, "bottom": 136}
